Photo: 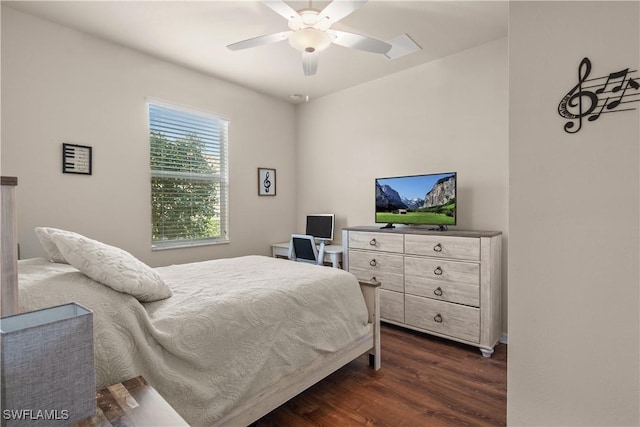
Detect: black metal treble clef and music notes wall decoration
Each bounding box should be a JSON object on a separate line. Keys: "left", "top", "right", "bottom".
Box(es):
{"left": 558, "top": 58, "right": 640, "bottom": 133}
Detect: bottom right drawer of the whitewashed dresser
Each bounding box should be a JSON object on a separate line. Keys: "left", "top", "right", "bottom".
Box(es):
{"left": 404, "top": 295, "right": 480, "bottom": 343}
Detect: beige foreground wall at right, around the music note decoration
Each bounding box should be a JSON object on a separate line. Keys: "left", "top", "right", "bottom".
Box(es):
{"left": 507, "top": 1, "right": 640, "bottom": 426}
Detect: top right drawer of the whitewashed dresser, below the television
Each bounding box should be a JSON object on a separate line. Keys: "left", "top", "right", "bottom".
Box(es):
{"left": 404, "top": 234, "right": 480, "bottom": 261}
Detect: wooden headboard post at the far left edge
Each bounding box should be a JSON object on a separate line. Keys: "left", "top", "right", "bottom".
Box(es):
{"left": 0, "top": 176, "right": 18, "bottom": 316}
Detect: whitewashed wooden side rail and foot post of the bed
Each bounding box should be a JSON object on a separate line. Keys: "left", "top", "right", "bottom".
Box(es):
{"left": 215, "top": 281, "right": 381, "bottom": 426}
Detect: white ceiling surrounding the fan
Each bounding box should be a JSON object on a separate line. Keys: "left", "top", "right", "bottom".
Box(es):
{"left": 3, "top": 0, "right": 509, "bottom": 101}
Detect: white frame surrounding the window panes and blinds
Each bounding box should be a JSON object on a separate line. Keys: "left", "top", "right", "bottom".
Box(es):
{"left": 146, "top": 98, "right": 231, "bottom": 251}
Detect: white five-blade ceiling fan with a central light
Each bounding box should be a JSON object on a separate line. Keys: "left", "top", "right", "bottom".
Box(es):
{"left": 227, "top": 0, "right": 391, "bottom": 76}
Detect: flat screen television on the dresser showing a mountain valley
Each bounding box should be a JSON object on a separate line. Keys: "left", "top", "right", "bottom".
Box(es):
{"left": 376, "top": 172, "right": 457, "bottom": 229}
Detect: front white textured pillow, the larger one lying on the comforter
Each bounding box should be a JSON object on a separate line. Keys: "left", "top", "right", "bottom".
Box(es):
{"left": 51, "top": 230, "right": 173, "bottom": 302}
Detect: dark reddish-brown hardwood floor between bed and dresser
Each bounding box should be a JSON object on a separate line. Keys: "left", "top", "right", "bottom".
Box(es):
{"left": 254, "top": 324, "right": 507, "bottom": 427}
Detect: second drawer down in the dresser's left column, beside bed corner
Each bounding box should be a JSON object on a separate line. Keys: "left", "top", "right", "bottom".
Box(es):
{"left": 349, "top": 250, "right": 404, "bottom": 292}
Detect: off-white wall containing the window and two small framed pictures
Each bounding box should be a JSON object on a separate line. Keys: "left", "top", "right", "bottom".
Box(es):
{"left": 2, "top": 5, "right": 295, "bottom": 265}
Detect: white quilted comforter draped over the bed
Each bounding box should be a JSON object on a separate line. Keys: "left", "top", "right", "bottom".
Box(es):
{"left": 19, "top": 256, "right": 368, "bottom": 426}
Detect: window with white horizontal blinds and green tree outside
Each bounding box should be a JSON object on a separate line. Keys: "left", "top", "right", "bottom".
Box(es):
{"left": 149, "top": 102, "right": 229, "bottom": 249}
